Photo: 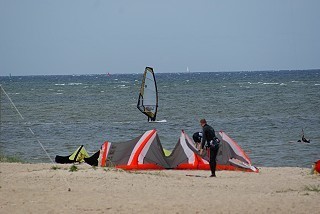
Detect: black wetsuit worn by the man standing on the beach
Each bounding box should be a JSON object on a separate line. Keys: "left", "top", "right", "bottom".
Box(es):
{"left": 201, "top": 124, "right": 219, "bottom": 176}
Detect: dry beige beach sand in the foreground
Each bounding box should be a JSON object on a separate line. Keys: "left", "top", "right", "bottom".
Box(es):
{"left": 0, "top": 163, "right": 320, "bottom": 214}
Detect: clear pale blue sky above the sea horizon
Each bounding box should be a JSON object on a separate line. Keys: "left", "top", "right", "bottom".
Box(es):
{"left": 0, "top": 0, "right": 320, "bottom": 76}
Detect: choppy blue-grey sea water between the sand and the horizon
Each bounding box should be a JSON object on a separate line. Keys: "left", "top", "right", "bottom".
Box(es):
{"left": 0, "top": 70, "right": 320, "bottom": 167}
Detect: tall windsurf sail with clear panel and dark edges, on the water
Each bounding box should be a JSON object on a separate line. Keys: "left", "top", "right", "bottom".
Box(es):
{"left": 137, "top": 67, "right": 158, "bottom": 121}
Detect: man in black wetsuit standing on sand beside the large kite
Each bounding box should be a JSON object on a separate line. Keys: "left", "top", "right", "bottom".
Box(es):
{"left": 200, "top": 119, "right": 220, "bottom": 177}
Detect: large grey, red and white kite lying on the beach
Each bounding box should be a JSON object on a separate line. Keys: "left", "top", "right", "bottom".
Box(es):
{"left": 79, "top": 129, "right": 259, "bottom": 172}
